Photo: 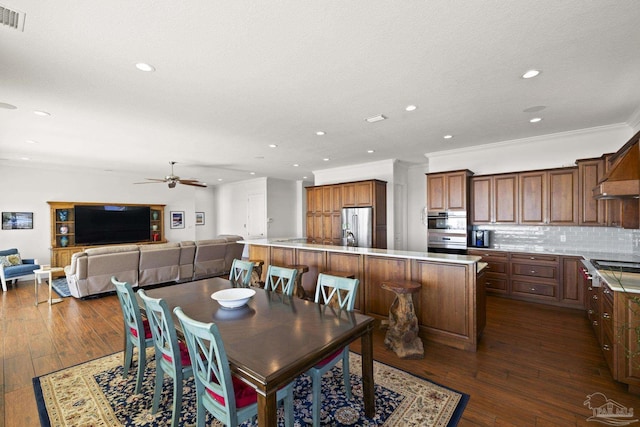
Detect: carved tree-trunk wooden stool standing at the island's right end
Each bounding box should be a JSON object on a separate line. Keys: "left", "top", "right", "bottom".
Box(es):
{"left": 381, "top": 280, "right": 424, "bottom": 359}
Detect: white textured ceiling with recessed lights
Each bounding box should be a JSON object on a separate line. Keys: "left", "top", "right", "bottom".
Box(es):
{"left": 0, "top": 0, "right": 640, "bottom": 184}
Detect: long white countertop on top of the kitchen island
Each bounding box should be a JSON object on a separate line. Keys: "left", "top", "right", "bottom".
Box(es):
{"left": 238, "top": 238, "right": 481, "bottom": 264}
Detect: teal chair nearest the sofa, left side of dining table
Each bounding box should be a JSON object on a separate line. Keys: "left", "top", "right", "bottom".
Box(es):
{"left": 111, "top": 276, "right": 153, "bottom": 394}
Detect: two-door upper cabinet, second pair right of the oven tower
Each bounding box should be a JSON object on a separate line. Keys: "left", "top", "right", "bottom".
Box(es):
{"left": 518, "top": 168, "right": 578, "bottom": 225}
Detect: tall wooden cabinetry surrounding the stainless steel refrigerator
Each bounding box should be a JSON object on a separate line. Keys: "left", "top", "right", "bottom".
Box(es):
{"left": 306, "top": 180, "right": 387, "bottom": 249}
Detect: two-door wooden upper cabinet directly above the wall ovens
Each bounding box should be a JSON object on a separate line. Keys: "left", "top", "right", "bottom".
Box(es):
{"left": 427, "top": 169, "right": 473, "bottom": 211}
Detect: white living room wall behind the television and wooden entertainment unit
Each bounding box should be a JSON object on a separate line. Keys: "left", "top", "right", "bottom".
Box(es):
{"left": 0, "top": 163, "right": 213, "bottom": 264}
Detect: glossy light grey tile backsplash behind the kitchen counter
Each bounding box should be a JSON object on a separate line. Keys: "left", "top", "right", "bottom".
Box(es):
{"left": 474, "top": 225, "right": 640, "bottom": 255}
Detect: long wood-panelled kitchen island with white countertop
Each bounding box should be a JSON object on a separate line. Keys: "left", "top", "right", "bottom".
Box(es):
{"left": 238, "top": 239, "right": 486, "bottom": 351}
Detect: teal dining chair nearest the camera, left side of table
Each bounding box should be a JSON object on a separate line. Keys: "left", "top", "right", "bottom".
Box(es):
{"left": 173, "top": 307, "right": 293, "bottom": 427}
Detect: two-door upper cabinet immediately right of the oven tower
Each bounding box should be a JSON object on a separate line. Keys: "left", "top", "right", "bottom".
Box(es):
{"left": 471, "top": 174, "right": 518, "bottom": 225}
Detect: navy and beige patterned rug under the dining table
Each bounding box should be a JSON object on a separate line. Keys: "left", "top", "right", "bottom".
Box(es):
{"left": 33, "top": 353, "right": 469, "bottom": 427}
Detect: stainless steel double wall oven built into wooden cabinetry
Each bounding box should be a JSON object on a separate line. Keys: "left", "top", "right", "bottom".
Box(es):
{"left": 427, "top": 211, "right": 469, "bottom": 255}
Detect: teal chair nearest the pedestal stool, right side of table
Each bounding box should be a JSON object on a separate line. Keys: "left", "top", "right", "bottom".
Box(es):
{"left": 307, "top": 273, "right": 360, "bottom": 427}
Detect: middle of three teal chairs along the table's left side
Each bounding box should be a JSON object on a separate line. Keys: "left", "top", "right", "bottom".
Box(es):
{"left": 138, "top": 289, "right": 193, "bottom": 427}
